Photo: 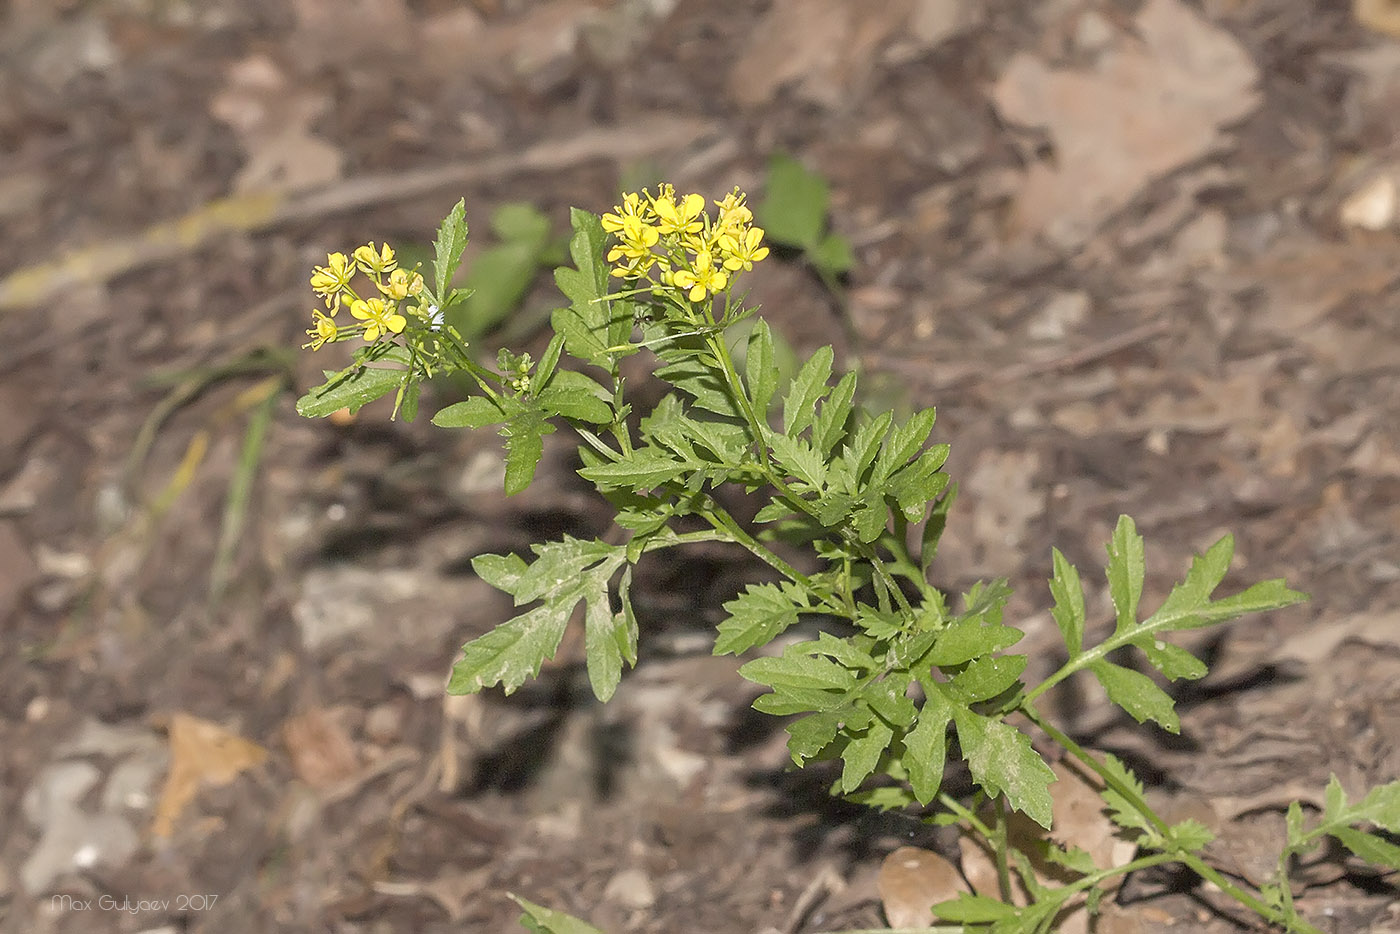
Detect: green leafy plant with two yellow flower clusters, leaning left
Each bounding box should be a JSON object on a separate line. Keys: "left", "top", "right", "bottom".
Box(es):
{"left": 289, "top": 193, "right": 1400, "bottom": 931}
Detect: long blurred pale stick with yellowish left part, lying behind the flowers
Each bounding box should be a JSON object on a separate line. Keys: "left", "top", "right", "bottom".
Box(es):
{"left": 0, "top": 118, "right": 717, "bottom": 311}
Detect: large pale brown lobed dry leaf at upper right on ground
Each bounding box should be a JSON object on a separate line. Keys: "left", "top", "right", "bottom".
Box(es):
{"left": 993, "top": 0, "right": 1260, "bottom": 248}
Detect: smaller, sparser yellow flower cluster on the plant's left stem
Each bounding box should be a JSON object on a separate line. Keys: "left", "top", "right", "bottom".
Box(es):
{"left": 302, "top": 242, "right": 433, "bottom": 350}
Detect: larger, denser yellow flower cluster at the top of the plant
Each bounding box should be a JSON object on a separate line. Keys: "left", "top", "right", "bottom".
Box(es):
{"left": 602, "top": 185, "right": 769, "bottom": 301}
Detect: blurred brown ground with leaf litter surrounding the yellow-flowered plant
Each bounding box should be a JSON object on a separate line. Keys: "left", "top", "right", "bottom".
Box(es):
{"left": 0, "top": 0, "right": 1400, "bottom": 934}
